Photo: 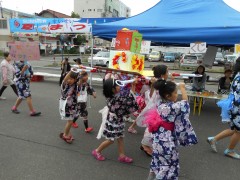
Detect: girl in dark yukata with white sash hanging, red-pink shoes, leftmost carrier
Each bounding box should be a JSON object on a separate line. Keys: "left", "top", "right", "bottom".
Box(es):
{"left": 59, "top": 71, "right": 79, "bottom": 143}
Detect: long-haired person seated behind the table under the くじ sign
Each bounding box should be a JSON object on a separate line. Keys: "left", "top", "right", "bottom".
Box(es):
{"left": 192, "top": 65, "right": 207, "bottom": 91}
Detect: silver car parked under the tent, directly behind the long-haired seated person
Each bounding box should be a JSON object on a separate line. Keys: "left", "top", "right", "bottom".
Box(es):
{"left": 180, "top": 54, "right": 203, "bottom": 67}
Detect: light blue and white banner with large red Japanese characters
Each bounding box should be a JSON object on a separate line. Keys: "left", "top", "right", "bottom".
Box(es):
{"left": 9, "top": 18, "right": 92, "bottom": 33}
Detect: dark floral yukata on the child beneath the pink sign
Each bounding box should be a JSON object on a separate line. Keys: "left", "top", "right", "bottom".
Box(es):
{"left": 14, "top": 62, "right": 33, "bottom": 99}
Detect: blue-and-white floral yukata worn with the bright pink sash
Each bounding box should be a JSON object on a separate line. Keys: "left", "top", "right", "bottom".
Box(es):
{"left": 150, "top": 100, "right": 197, "bottom": 180}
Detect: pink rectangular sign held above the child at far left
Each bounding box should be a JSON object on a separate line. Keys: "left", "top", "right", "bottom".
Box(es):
{"left": 8, "top": 41, "right": 40, "bottom": 61}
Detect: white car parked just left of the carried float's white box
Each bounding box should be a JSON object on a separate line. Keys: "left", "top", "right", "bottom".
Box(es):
{"left": 88, "top": 51, "right": 110, "bottom": 67}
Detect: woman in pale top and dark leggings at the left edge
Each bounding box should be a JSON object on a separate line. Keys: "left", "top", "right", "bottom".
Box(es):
{"left": 0, "top": 52, "right": 18, "bottom": 99}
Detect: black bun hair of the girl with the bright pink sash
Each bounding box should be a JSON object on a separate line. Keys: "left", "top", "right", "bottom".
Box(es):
{"left": 153, "top": 79, "right": 177, "bottom": 99}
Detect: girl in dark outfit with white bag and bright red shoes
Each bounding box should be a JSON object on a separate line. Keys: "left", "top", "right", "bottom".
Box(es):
{"left": 72, "top": 71, "right": 97, "bottom": 133}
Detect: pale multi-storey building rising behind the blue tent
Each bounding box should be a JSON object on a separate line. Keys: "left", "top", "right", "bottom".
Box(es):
{"left": 74, "top": 0, "right": 131, "bottom": 18}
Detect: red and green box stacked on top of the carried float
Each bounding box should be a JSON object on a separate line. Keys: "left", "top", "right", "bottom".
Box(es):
{"left": 115, "top": 30, "right": 142, "bottom": 53}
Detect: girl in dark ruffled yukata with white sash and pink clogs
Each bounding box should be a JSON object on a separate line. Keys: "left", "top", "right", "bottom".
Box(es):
{"left": 92, "top": 78, "right": 138, "bottom": 163}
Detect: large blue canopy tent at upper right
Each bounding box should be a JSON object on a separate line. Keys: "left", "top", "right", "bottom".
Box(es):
{"left": 93, "top": 0, "right": 240, "bottom": 45}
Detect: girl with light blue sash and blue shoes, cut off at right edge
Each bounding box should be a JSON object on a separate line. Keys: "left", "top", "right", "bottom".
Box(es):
{"left": 207, "top": 57, "right": 240, "bottom": 159}
